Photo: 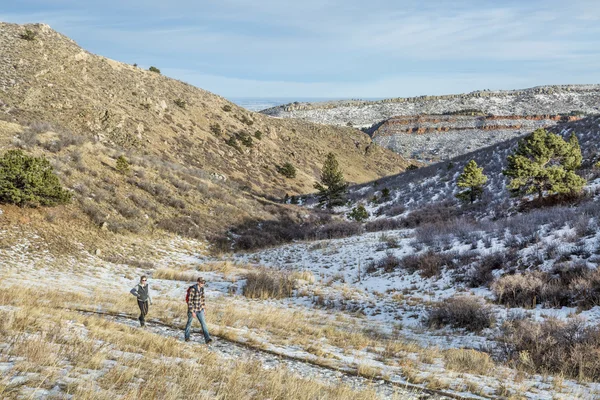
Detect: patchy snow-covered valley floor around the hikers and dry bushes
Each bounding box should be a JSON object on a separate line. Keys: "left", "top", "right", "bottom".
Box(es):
{"left": 0, "top": 208, "right": 600, "bottom": 399}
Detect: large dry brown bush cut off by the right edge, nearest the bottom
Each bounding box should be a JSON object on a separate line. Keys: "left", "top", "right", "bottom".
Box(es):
{"left": 498, "top": 318, "right": 600, "bottom": 382}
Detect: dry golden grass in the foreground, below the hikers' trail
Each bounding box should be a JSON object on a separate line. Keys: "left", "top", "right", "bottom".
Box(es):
{"left": 0, "top": 288, "right": 386, "bottom": 400}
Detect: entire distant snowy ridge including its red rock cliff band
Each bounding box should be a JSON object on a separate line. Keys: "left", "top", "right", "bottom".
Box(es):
{"left": 261, "top": 85, "right": 600, "bottom": 162}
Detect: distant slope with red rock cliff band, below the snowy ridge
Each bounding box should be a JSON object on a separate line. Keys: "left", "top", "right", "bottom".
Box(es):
{"left": 369, "top": 115, "right": 581, "bottom": 162}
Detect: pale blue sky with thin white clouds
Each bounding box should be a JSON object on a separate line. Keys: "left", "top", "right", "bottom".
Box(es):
{"left": 0, "top": 0, "right": 600, "bottom": 98}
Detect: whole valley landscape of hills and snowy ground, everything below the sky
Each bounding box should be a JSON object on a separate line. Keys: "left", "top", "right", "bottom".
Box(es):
{"left": 0, "top": 23, "right": 600, "bottom": 400}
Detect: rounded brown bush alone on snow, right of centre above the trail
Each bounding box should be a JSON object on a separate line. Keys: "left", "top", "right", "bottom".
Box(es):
{"left": 424, "top": 296, "right": 495, "bottom": 332}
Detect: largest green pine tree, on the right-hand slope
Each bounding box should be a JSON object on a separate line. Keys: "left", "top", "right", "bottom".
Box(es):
{"left": 503, "top": 129, "right": 585, "bottom": 198}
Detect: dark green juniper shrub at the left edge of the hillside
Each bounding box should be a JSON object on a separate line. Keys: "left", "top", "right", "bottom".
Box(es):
{"left": 0, "top": 150, "right": 71, "bottom": 207}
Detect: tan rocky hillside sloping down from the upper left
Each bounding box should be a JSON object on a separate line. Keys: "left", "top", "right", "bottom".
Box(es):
{"left": 0, "top": 23, "right": 407, "bottom": 244}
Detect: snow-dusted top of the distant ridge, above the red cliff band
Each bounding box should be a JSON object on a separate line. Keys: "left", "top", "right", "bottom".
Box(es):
{"left": 261, "top": 85, "right": 600, "bottom": 128}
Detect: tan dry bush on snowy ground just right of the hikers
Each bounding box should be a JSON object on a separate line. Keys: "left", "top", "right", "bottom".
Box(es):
{"left": 242, "top": 269, "right": 296, "bottom": 299}
